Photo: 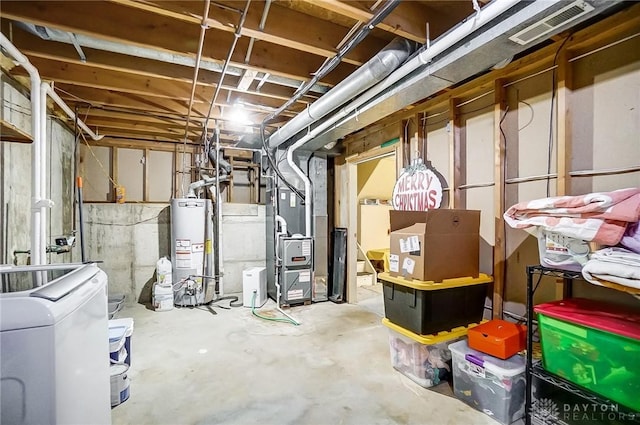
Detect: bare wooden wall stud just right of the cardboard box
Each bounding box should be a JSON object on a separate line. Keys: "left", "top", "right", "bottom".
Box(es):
{"left": 493, "top": 79, "right": 507, "bottom": 319}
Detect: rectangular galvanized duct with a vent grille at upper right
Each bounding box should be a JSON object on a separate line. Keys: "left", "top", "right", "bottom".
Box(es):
{"left": 294, "top": 0, "right": 622, "bottom": 151}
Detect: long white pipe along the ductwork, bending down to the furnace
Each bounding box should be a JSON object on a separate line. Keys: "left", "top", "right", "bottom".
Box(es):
{"left": 287, "top": 0, "right": 520, "bottom": 237}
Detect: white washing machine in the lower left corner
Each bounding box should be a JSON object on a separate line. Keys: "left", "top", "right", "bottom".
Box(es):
{"left": 0, "top": 264, "right": 111, "bottom": 425}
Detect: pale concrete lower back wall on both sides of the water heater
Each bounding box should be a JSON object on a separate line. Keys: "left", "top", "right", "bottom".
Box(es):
{"left": 84, "top": 203, "right": 266, "bottom": 304}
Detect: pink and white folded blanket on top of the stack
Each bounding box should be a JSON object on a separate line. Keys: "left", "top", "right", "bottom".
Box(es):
{"left": 504, "top": 188, "right": 640, "bottom": 245}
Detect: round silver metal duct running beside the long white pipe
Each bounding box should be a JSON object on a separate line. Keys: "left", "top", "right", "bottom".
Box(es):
{"left": 269, "top": 37, "right": 413, "bottom": 149}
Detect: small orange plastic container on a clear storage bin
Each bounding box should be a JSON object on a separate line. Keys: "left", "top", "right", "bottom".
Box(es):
{"left": 467, "top": 319, "right": 527, "bottom": 360}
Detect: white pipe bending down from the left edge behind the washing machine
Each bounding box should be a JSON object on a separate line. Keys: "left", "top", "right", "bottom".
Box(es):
{"left": 0, "top": 33, "right": 42, "bottom": 270}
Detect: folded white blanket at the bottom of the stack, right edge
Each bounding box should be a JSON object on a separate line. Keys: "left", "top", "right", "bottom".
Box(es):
{"left": 582, "top": 247, "right": 640, "bottom": 289}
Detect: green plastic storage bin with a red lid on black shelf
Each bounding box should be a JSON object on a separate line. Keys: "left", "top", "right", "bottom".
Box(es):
{"left": 535, "top": 298, "right": 640, "bottom": 411}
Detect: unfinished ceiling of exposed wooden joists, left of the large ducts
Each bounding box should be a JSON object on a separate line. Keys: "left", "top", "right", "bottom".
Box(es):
{"left": 0, "top": 0, "right": 483, "bottom": 143}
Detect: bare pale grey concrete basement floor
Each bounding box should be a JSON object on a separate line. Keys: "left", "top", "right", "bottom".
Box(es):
{"left": 112, "top": 284, "right": 497, "bottom": 425}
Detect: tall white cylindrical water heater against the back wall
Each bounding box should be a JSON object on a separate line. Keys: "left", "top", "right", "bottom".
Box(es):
{"left": 171, "top": 198, "right": 215, "bottom": 306}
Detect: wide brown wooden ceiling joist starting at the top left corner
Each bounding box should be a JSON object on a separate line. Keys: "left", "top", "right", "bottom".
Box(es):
{"left": 2, "top": 1, "right": 355, "bottom": 85}
